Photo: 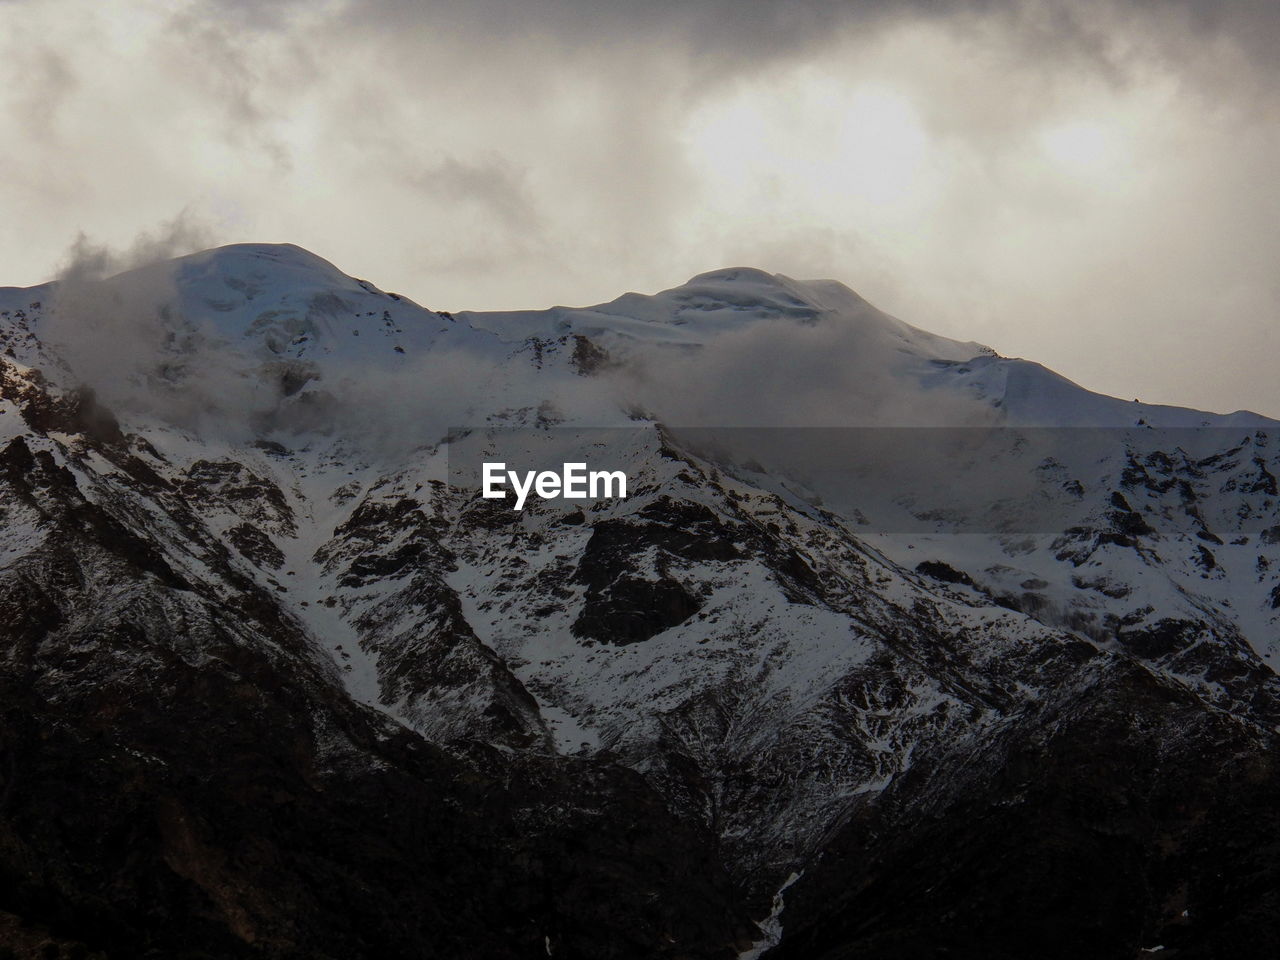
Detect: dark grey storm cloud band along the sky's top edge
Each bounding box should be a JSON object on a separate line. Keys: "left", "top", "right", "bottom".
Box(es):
{"left": 194, "top": 0, "right": 1280, "bottom": 80}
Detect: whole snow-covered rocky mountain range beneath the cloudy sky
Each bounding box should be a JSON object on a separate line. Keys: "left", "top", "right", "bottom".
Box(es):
{"left": 0, "top": 244, "right": 1280, "bottom": 959}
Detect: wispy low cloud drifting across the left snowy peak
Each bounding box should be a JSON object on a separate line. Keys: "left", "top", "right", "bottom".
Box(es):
{"left": 38, "top": 222, "right": 616, "bottom": 454}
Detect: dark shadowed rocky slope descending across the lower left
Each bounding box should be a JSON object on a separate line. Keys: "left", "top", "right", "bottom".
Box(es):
{"left": 0, "top": 358, "right": 754, "bottom": 957}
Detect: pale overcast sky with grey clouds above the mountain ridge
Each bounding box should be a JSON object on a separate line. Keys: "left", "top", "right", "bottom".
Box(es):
{"left": 0, "top": 0, "right": 1280, "bottom": 416}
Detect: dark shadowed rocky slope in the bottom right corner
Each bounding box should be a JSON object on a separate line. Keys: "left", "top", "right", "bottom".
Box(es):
{"left": 771, "top": 667, "right": 1280, "bottom": 960}
